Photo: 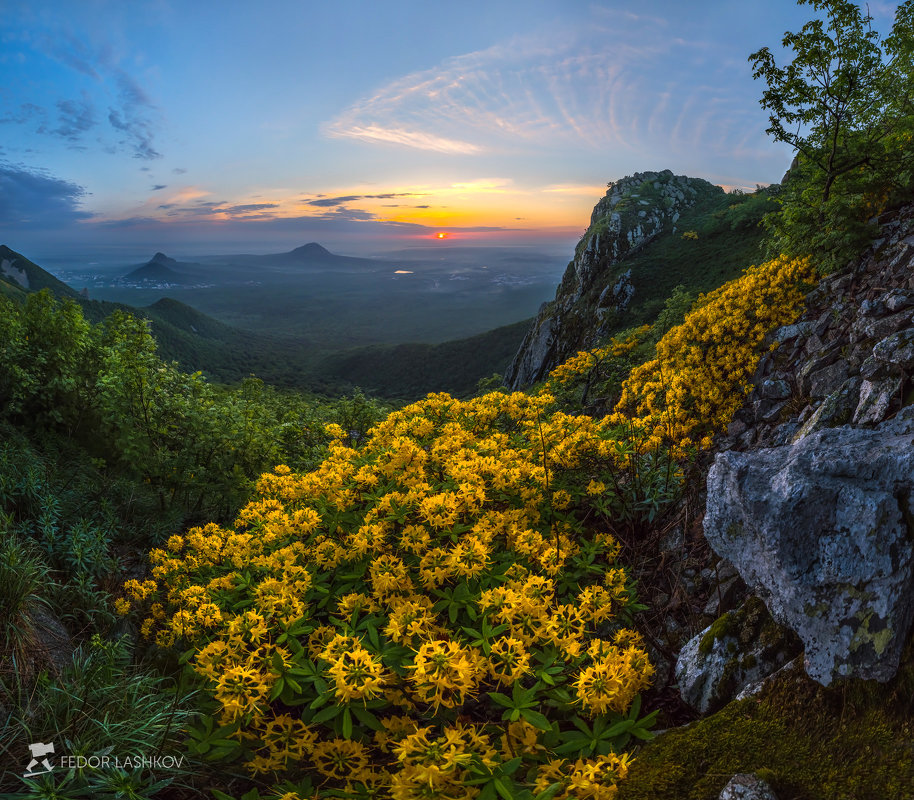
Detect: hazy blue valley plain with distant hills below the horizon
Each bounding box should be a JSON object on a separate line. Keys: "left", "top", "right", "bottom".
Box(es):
{"left": 47, "top": 242, "right": 570, "bottom": 351}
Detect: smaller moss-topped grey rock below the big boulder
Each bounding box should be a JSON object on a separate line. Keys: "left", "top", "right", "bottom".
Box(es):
{"left": 676, "top": 597, "right": 800, "bottom": 714}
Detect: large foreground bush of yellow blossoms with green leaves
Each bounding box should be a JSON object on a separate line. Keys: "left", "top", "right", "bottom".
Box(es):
{"left": 126, "top": 393, "right": 653, "bottom": 800}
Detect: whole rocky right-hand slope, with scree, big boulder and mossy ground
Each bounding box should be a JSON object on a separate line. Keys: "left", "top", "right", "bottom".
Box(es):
{"left": 619, "top": 206, "right": 914, "bottom": 800}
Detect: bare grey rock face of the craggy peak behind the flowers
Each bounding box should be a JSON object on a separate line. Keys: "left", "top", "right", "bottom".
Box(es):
{"left": 505, "top": 170, "right": 723, "bottom": 389}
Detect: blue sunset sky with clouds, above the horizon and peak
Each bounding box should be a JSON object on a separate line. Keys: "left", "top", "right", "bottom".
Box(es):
{"left": 0, "top": 0, "right": 895, "bottom": 260}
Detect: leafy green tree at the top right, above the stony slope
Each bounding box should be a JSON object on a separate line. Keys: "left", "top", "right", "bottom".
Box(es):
{"left": 749, "top": 0, "right": 914, "bottom": 269}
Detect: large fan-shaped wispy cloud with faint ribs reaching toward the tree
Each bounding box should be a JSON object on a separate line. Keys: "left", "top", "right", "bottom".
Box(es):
{"left": 324, "top": 18, "right": 763, "bottom": 167}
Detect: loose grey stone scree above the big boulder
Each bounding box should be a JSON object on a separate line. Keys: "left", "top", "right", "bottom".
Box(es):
{"left": 718, "top": 206, "right": 914, "bottom": 450}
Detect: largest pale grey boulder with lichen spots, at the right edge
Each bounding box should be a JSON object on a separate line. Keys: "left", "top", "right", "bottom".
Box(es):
{"left": 704, "top": 408, "right": 914, "bottom": 686}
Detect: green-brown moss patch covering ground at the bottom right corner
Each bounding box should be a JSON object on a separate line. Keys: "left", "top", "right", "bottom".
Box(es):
{"left": 618, "top": 647, "right": 914, "bottom": 800}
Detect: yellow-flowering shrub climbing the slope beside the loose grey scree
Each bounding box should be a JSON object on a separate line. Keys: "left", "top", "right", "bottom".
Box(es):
{"left": 612, "top": 257, "right": 814, "bottom": 454}
